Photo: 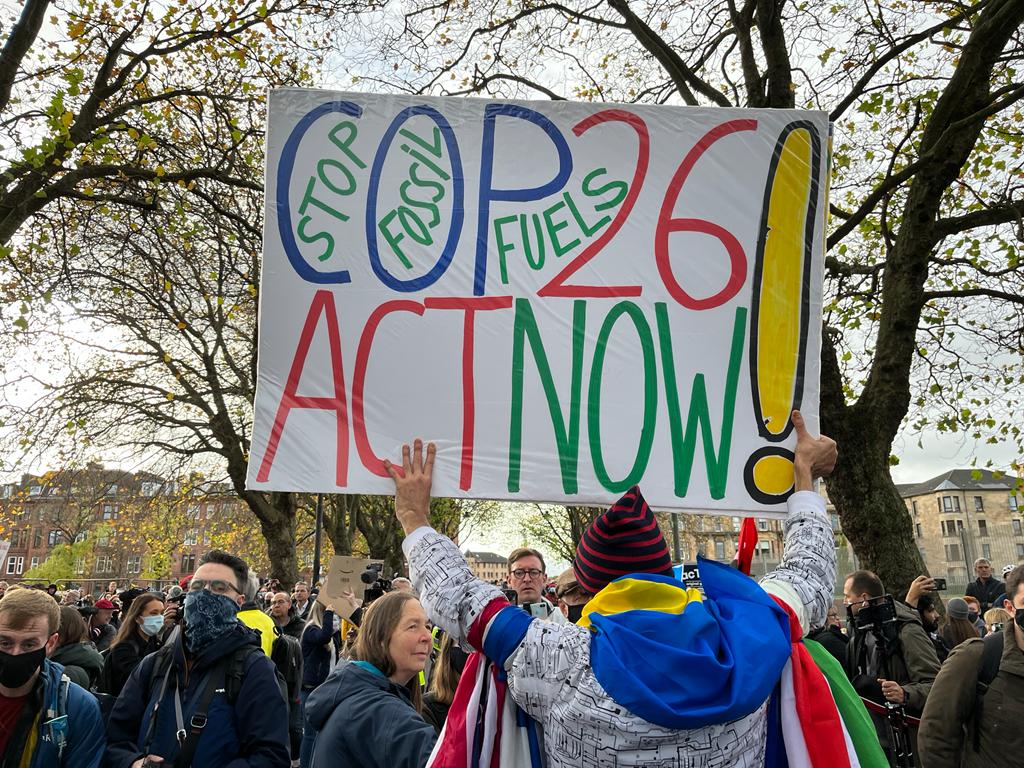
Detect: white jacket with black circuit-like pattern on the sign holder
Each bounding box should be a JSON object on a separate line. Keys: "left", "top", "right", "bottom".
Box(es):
{"left": 403, "top": 492, "right": 836, "bottom": 768}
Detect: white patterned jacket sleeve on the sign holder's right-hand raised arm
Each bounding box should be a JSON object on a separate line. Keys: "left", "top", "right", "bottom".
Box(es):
{"left": 761, "top": 490, "right": 836, "bottom": 635}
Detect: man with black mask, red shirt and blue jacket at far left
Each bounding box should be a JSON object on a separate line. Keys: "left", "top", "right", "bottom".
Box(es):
{"left": 0, "top": 589, "right": 104, "bottom": 768}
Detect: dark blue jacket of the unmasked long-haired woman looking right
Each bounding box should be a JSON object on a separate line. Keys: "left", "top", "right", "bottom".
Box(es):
{"left": 306, "top": 659, "right": 437, "bottom": 768}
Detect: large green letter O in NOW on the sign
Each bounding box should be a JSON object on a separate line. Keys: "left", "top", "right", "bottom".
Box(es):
{"left": 587, "top": 301, "right": 657, "bottom": 494}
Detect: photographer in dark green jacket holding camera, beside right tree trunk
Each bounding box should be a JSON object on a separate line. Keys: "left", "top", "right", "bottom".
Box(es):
{"left": 843, "top": 570, "right": 939, "bottom": 768}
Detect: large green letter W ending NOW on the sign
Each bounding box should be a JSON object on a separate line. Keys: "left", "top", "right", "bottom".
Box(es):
{"left": 654, "top": 302, "right": 746, "bottom": 499}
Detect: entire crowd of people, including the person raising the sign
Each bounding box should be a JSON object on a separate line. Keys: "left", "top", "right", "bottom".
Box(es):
{"left": 0, "top": 413, "right": 1024, "bottom": 768}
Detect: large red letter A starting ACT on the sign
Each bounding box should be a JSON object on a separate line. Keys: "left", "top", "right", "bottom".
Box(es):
{"left": 256, "top": 291, "right": 348, "bottom": 487}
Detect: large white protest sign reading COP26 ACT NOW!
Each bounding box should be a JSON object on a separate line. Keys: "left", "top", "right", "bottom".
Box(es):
{"left": 247, "top": 89, "right": 828, "bottom": 514}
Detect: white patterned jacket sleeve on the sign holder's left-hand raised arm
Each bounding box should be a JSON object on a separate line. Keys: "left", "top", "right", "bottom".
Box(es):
{"left": 401, "top": 526, "right": 503, "bottom": 648}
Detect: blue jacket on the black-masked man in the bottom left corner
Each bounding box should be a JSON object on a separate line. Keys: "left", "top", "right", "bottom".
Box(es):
{"left": 29, "top": 659, "right": 105, "bottom": 768}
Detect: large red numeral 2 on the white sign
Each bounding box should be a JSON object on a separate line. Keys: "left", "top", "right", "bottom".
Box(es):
{"left": 537, "top": 110, "right": 650, "bottom": 299}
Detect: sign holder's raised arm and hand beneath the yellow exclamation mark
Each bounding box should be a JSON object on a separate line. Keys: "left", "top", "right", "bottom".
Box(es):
{"left": 761, "top": 411, "right": 838, "bottom": 633}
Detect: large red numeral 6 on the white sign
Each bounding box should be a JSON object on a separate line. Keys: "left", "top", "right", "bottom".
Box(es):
{"left": 654, "top": 120, "right": 758, "bottom": 309}
